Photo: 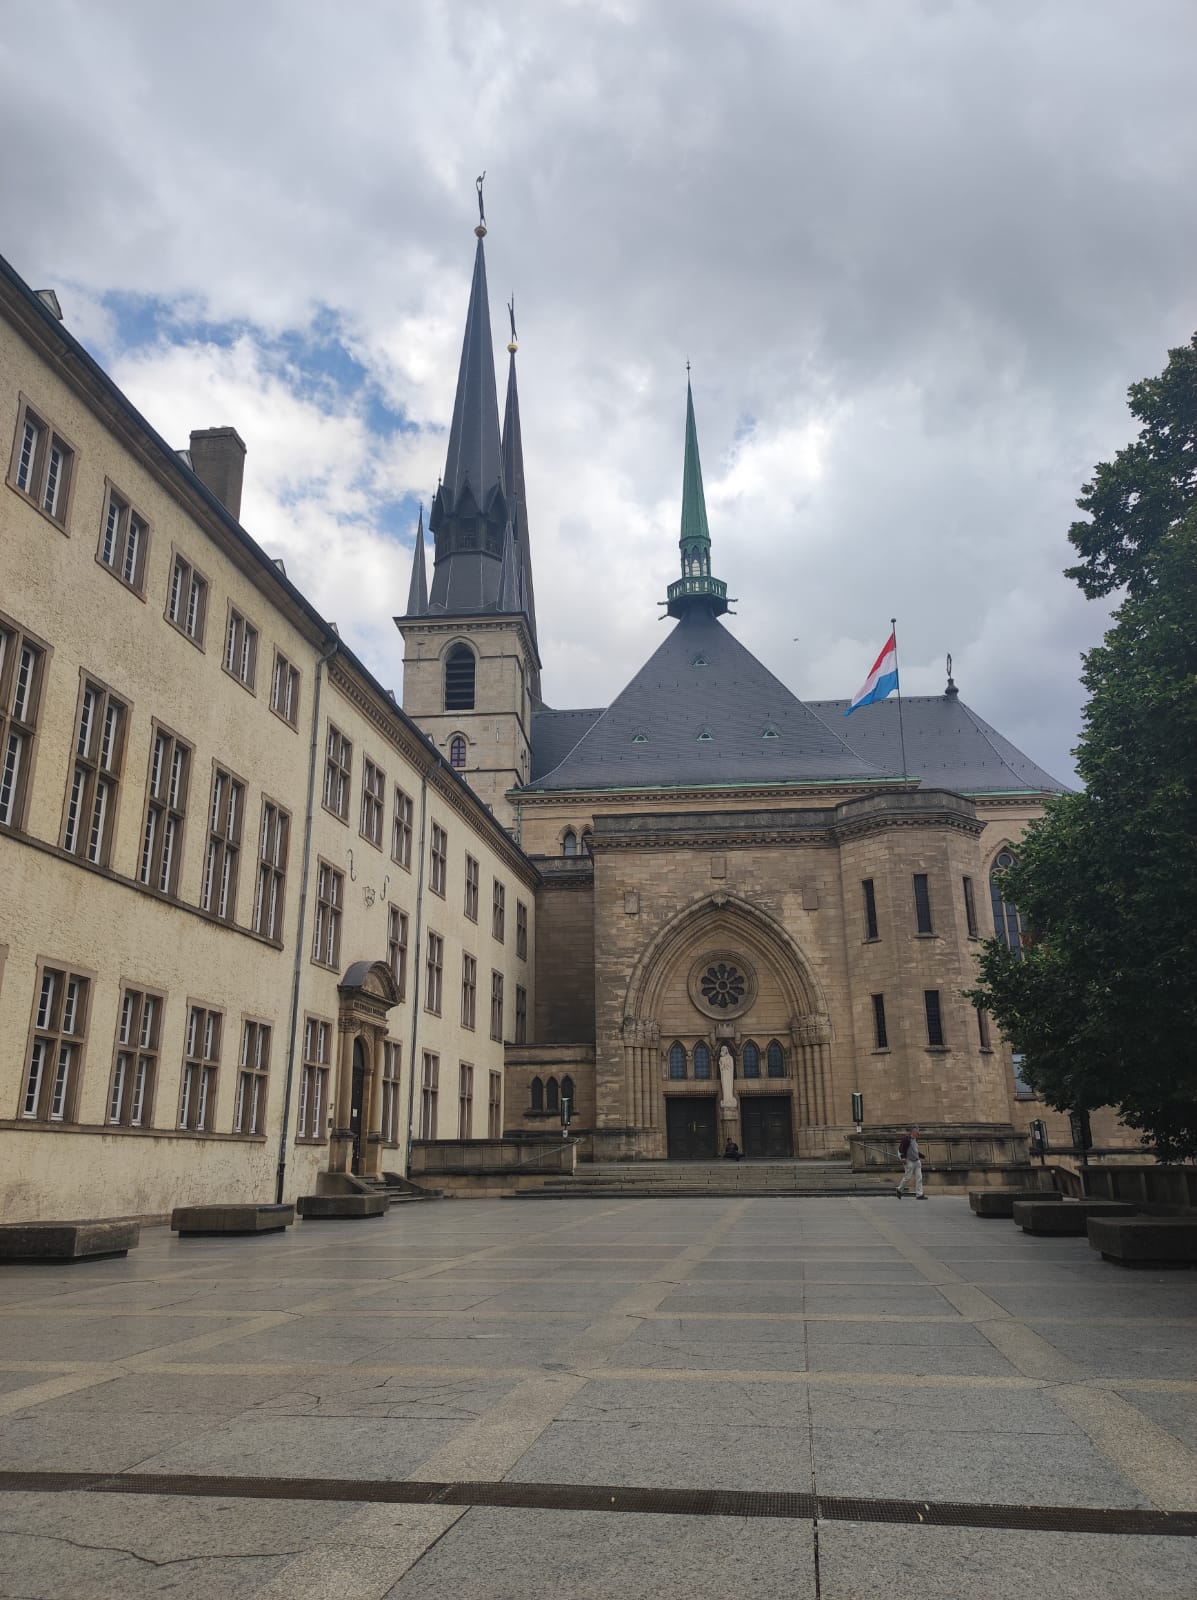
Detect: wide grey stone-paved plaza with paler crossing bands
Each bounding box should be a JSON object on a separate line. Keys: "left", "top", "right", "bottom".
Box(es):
{"left": 0, "top": 1197, "right": 1197, "bottom": 1600}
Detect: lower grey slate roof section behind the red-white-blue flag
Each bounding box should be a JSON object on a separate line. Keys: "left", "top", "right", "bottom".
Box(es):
{"left": 807, "top": 694, "right": 1069, "bottom": 794}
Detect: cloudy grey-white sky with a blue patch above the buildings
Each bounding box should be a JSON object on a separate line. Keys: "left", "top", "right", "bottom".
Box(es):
{"left": 0, "top": 0, "right": 1197, "bottom": 781}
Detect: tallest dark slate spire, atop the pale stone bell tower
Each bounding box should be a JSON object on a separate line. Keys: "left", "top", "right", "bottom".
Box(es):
{"left": 429, "top": 179, "right": 507, "bottom": 611}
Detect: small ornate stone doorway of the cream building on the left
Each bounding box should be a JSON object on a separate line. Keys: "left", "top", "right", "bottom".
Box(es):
{"left": 328, "top": 962, "right": 398, "bottom": 1178}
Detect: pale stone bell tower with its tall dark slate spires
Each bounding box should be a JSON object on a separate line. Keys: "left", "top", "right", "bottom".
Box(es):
{"left": 395, "top": 174, "right": 541, "bottom": 827}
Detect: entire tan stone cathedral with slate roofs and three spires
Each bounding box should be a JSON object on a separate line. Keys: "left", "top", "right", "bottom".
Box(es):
{"left": 395, "top": 212, "right": 1063, "bottom": 1160}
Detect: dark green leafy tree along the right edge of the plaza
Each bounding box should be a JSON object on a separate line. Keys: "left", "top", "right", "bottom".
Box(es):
{"left": 971, "top": 350, "right": 1197, "bottom": 1160}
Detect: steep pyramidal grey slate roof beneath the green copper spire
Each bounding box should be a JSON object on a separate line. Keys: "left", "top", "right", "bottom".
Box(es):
{"left": 530, "top": 610, "right": 887, "bottom": 790}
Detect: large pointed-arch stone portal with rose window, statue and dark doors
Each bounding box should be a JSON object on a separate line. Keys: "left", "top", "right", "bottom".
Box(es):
{"left": 608, "top": 894, "right": 834, "bottom": 1158}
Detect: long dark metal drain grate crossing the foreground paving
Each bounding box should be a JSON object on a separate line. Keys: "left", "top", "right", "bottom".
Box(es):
{"left": 0, "top": 1472, "right": 1197, "bottom": 1539}
